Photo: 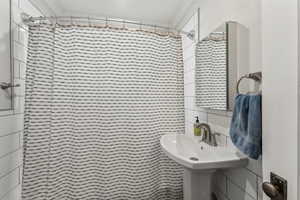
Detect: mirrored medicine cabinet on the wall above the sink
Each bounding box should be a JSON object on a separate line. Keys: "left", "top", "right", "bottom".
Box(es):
{"left": 195, "top": 22, "right": 249, "bottom": 111}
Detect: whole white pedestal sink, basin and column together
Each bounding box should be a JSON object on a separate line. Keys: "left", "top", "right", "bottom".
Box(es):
{"left": 160, "top": 134, "right": 248, "bottom": 200}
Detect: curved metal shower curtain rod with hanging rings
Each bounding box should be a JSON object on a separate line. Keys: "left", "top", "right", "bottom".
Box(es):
{"left": 21, "top": 13, "right": 194, "bottom": 40}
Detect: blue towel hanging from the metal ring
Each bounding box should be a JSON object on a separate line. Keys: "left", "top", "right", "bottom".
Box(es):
{"left": 230, "top": 94, "right": 262, "bottom": 160}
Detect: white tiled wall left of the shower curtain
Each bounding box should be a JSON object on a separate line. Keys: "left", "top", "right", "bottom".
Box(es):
{"left": 0, "top": 0, "right": 41, "bottom": 200}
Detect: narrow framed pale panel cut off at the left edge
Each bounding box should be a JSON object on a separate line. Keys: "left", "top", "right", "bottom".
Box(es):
{"left": 0, "top": 0, "right": 13, "bottom": 111}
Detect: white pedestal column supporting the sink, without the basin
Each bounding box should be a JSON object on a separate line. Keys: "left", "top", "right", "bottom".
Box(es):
{"left": 183, "top": 168, "right": 216, "bottom": 200}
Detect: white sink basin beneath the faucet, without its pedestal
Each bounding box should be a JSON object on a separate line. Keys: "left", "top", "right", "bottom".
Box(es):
{"left": 160, "top": 134, "right": 248, "bottom": 170}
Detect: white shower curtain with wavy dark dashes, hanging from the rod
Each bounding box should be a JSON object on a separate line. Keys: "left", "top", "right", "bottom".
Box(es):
{"left": 22, "top": 24, "right": 184, "bottom": 200}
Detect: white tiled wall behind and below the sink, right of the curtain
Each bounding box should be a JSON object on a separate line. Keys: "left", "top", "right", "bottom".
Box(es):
{"left": 182, "top": 12, "right": 262, "bottom": 200}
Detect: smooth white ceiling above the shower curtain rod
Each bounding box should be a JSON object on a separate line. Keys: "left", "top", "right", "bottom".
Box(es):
{"left": 31, "top": 0, "right": 195, "bottom": 27}
